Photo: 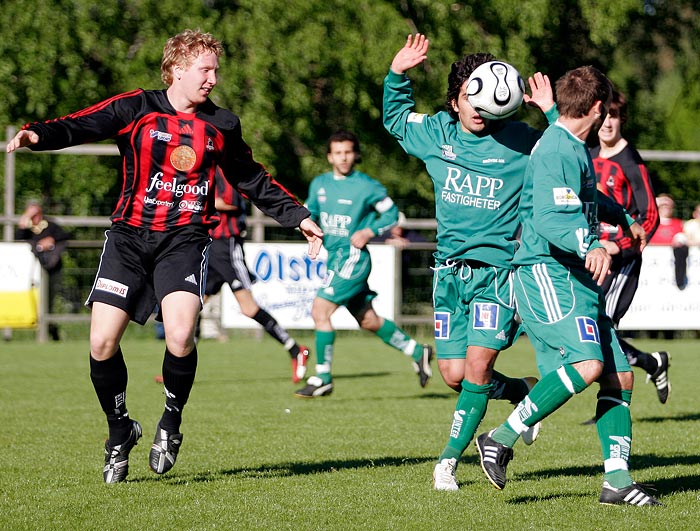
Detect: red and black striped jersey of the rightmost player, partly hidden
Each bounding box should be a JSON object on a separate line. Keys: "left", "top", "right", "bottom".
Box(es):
{"left": 591, "top": 144, "right": 659, "bottom": 253}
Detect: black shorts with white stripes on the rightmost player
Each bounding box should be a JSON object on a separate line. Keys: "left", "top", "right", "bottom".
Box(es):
{"left": 601, "top": 253, "right": 642, "bottom": 326}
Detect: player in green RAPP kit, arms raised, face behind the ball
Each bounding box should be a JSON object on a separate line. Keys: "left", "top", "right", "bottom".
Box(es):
{"left": 384, "top": 34, "right": 557, "bottom": 490}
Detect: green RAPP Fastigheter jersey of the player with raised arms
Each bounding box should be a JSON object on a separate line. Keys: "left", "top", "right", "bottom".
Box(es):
{"left": 384, "top": 71, "right": 557, "bottom": 267}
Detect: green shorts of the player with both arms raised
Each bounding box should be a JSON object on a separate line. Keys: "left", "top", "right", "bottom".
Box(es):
{"left": 433, "top": 260, "right": 519, "bottom": 359}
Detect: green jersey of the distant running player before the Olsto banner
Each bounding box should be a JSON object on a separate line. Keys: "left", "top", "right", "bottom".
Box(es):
{"left": 305, "top": 171, "right": 399, "bottom": 278}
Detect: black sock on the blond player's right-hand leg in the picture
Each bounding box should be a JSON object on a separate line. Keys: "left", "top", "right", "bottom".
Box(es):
{"left": 160, "top": 346, "right": 197, "bottom": 433}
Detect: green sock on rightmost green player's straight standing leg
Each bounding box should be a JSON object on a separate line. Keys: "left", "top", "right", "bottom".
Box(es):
{"left": 596, "top": 389, "right": 632, "bottom": 489}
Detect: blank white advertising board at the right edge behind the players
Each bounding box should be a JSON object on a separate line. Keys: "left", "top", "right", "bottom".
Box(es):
{"left": 620, "top": 245, "right": 700, "bottom": 330}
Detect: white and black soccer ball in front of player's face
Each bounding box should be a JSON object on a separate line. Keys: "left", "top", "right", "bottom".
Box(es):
{"left": 467, "top": 61, "right": 525, "bottom": 120}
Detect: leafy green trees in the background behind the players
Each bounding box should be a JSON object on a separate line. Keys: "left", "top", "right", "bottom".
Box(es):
{"left": 0, "top": 0, "right": 700, "bottom": 217}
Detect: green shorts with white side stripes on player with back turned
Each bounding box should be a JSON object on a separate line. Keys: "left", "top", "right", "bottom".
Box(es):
{"left": 515, "top": 263, "right": 632, "bottom": 376}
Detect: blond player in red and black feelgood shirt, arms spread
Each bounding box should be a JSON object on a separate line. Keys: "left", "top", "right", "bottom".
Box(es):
{"left": 7, "top": 30, "right": 323, "bottom": 483}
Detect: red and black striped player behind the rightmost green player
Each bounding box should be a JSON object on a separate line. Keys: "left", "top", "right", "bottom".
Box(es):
{"left": 591, "top": 90, "right": 671, "bottom": 404}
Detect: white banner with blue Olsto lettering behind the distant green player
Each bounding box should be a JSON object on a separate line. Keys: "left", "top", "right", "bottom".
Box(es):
{"left": 221, "top": 242, "right": 396, "bottom": 330}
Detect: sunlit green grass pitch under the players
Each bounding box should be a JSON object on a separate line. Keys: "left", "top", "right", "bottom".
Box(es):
{"left": 0, "top": 329, "right": 700, "bottom": 531}
